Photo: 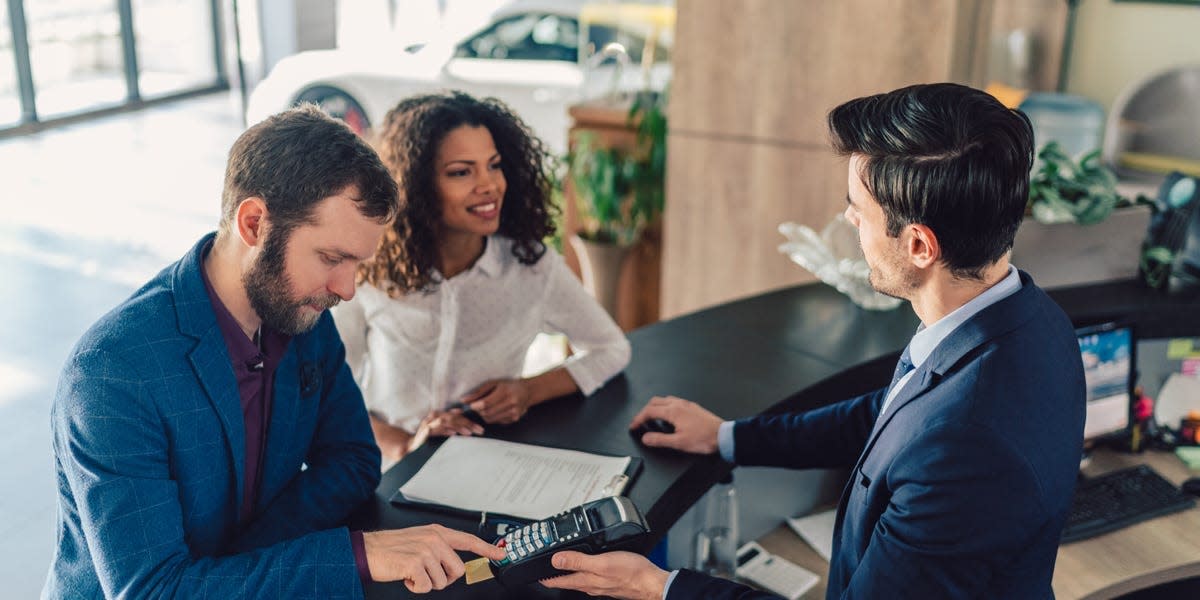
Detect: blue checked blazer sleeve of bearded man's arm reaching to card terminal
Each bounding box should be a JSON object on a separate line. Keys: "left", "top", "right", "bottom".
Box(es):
{"left": 52, "top": 350, "right": 362, "bottom": 598}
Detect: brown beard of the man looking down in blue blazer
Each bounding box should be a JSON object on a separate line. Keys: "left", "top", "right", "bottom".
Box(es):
{"left": 241, "top": 230, "right": 341, "bottom": 336}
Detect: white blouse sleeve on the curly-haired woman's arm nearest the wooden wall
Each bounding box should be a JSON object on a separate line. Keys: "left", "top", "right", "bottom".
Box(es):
{"left": 542, "top": 251, "right": 630, "bottom": 395}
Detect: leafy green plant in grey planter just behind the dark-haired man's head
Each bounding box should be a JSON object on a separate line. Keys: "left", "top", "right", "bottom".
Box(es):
{"left": 1013, "top": 142, "right": 1150, "bottom": 287}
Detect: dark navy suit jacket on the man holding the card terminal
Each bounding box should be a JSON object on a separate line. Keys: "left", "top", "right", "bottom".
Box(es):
{"left": 670, "top": 272, "right": 1086, "bottom": 600}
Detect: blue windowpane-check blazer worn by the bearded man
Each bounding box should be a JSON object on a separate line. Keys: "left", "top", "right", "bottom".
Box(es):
{"left": 42, "top": 234, "right": 379, "bottom": 599}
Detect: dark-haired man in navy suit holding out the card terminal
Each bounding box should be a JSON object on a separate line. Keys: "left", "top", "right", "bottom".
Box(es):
{"left": 546, "top": 84, "right": 1085, "bottom": 600}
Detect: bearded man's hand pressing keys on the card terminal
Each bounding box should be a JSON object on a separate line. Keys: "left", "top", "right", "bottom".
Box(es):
{"left": 362, "top": 524, "right": 504, "bottom": 594}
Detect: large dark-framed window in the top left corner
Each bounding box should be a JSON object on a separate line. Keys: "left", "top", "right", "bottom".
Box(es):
{"left": 0, "top": 0, "right": 228, "bottom": 128}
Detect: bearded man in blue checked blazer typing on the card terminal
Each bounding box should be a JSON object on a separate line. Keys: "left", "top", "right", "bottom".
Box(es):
{"left": 42, "top": 107, "right": 504, "bottom": 599}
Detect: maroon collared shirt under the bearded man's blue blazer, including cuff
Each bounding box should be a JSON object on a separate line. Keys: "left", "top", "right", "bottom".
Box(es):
{"left": 200, "top": 242, "right": 372, "bottom": 583}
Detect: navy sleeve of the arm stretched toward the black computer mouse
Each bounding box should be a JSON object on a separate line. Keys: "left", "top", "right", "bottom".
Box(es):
{"left": 733, "top": 388, "right": 887, "bottom": 469}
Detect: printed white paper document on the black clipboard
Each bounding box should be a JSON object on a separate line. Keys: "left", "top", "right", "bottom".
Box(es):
{"left": 400, "top": 436, "right": 630, "bottom": 520}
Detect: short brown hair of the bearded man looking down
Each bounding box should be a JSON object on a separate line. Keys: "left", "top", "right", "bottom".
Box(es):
{"left": 221, "top": 104, "right": 397, "bottom": 235}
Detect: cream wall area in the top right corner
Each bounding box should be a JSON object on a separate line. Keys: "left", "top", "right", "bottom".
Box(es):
{"left": 1067, "top": 0, "right": 1200, "bottom": 112}
